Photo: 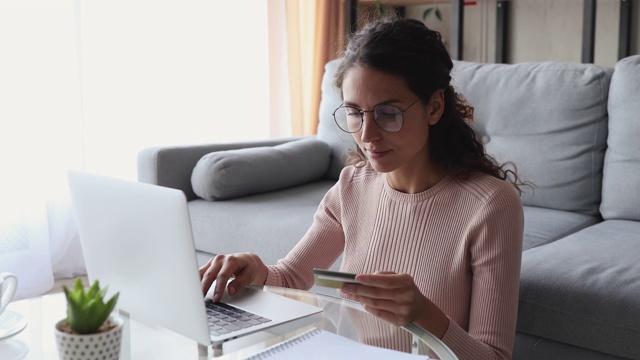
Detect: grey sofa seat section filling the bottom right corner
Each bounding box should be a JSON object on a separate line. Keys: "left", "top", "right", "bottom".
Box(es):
{"left": 517, "top": 220, "right": 640, "bottom": 359}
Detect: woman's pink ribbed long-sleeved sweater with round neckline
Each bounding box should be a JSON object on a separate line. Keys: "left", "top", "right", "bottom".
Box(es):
{"left": 266, "top": 165, "right": 524, "bottom": 360}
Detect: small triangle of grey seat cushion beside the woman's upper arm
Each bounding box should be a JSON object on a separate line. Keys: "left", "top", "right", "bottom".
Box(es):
{"left": 522, "top": 206, "right": 601, "bottom": 250}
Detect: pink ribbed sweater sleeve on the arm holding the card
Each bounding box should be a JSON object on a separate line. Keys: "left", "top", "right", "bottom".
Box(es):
{"left": 443, "top": 183, "right": 524, "bottom": 359}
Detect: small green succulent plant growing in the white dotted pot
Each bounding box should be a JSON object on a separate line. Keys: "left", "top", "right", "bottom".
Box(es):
{"left": 62, "top": 279, "right": 120, "bottom": 334}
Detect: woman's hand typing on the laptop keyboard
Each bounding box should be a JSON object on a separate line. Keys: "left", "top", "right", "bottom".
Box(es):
{"left": 200, "top": 253, "right": 269, "bottom": 302}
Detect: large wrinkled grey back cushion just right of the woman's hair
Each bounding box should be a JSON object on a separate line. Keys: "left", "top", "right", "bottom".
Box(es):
{"left": 453, "top": 61, "right": 613, "bottom": 215}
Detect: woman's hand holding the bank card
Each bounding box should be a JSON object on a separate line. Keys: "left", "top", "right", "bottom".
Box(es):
{"left": 341, "top": 272, "right": 449, "bottom": 338}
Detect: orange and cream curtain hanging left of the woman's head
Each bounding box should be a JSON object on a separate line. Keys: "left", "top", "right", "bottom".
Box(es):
{"left": 286, "top": 0, "right": 349, "bottom": 135}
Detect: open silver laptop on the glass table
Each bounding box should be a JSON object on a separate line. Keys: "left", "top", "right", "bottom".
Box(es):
{"left": 68, "top": 170, "right": 322, "bottom": 346}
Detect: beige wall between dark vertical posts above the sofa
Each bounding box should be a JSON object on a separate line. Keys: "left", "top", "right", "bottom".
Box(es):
{"left": 407, "top": 0, "right": 640, "bottom": 66}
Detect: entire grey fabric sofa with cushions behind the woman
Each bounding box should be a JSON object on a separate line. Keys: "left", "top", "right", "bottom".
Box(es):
{"left": 138, "top": 56, "right": 640, "bottom": 360}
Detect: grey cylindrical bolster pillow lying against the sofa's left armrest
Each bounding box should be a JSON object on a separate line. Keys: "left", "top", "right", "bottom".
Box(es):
{"left": 191, "top": 139, "right": 331, "bottom": 201}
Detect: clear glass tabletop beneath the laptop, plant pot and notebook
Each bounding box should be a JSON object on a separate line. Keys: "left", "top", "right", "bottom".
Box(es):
{"left": 0, "top": 286, "right": 457, "bottom": 360}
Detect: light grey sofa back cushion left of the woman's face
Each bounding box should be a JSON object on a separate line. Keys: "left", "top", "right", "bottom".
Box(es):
{"left": 317, "top": 59, "right": 356, "bottom": 180}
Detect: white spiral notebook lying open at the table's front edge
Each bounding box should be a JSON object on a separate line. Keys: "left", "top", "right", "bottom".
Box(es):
{"left": 247, "top": 328, "right": 430, "bottom": 360}
